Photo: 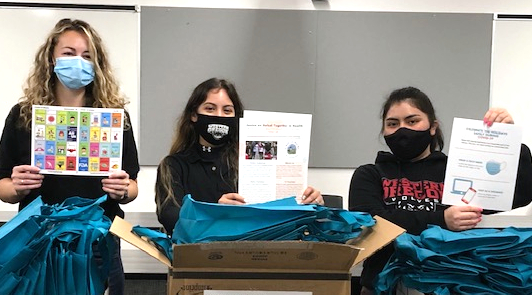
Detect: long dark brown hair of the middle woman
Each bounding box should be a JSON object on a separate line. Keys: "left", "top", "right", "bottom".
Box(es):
{"left": 155, "top": 78, "right": 244, "bottom": 214}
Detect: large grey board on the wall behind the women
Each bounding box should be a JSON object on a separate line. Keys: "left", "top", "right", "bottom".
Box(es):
{"left": 138, "top": 6, "right": 493, "bottom": 169}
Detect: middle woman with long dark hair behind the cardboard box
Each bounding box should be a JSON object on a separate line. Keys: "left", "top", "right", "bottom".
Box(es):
{"left": 155, "top": 78, "right": 323, "bottom": 234}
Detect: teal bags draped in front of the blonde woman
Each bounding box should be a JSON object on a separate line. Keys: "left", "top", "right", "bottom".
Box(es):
{"left": 0, "top": 196, "right": 114, "bottom": 295}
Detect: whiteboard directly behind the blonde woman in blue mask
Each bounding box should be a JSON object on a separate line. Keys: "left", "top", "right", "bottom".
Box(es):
{"left": 0, "top": 8, "right": 140, "bottom": 211}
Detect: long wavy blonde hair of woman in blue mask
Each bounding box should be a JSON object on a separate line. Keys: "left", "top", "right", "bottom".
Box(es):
{"left": 19, "top": 18, "right": 131, "bottom": 130}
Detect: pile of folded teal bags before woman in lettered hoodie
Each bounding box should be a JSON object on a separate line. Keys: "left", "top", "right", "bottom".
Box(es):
{"left": 376, "top": 226, "right": 532, "bottom": 295}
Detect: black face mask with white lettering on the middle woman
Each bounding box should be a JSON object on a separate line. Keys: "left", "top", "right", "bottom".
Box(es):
{"left": 193, "top": 114, "right": 238, "bottom": 146}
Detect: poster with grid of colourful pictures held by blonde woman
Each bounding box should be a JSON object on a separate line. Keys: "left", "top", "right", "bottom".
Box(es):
{"left": 31, "top": 105, "right": 124, "bottom": 176}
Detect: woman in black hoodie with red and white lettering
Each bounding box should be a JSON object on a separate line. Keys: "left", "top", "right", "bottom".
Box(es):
{"left": 349, "top": 87, "right": 532, "bottom": 294}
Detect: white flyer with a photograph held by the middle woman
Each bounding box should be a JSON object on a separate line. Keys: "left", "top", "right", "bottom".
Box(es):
{"left": 238, "top": 110, "right": 312, "bottom": 204}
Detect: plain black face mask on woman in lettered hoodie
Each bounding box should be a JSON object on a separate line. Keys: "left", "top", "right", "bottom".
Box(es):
{"left": 384, "top": 127, "right": 432, "bottom": 160}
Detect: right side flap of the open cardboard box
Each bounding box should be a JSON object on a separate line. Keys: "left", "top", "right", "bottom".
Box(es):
{"left": 350, "top": 215, "right": 405, "bottom": 265}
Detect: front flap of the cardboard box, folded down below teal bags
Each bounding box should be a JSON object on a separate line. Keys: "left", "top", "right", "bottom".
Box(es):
{"left": 173, "top": 241, "right": 359, "bottom": 273}
